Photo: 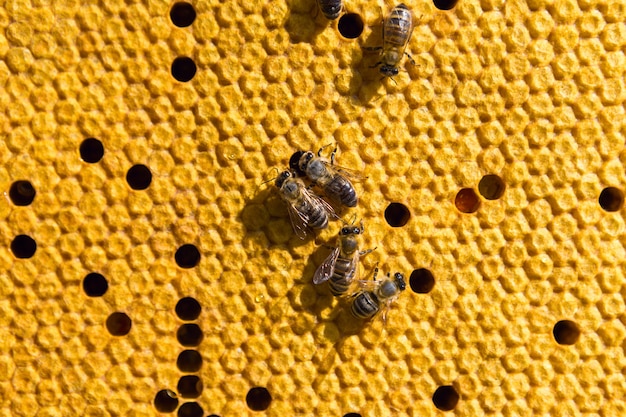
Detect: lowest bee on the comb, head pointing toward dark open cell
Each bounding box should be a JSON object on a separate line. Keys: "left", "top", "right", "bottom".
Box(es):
{"left": 351, "top": 268, "right": 406, "bottom": 323}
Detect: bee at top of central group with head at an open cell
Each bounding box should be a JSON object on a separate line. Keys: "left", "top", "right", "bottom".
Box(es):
{"left": 289, "top": 145, "right": 358, "bottom": 207}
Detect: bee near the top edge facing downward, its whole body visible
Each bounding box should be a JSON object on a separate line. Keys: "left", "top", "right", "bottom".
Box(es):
{"left": 367, "top": 3, "right": 415, "bottom": 77}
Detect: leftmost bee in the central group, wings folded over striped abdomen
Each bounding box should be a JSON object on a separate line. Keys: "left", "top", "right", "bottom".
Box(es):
{"left": 276, "top": 170, "right": 336, "bottom": 239}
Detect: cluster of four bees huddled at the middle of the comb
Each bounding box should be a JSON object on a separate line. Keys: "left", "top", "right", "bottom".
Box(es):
{"left": 275, "top": 148, "right": 406, "bottom": 320}
